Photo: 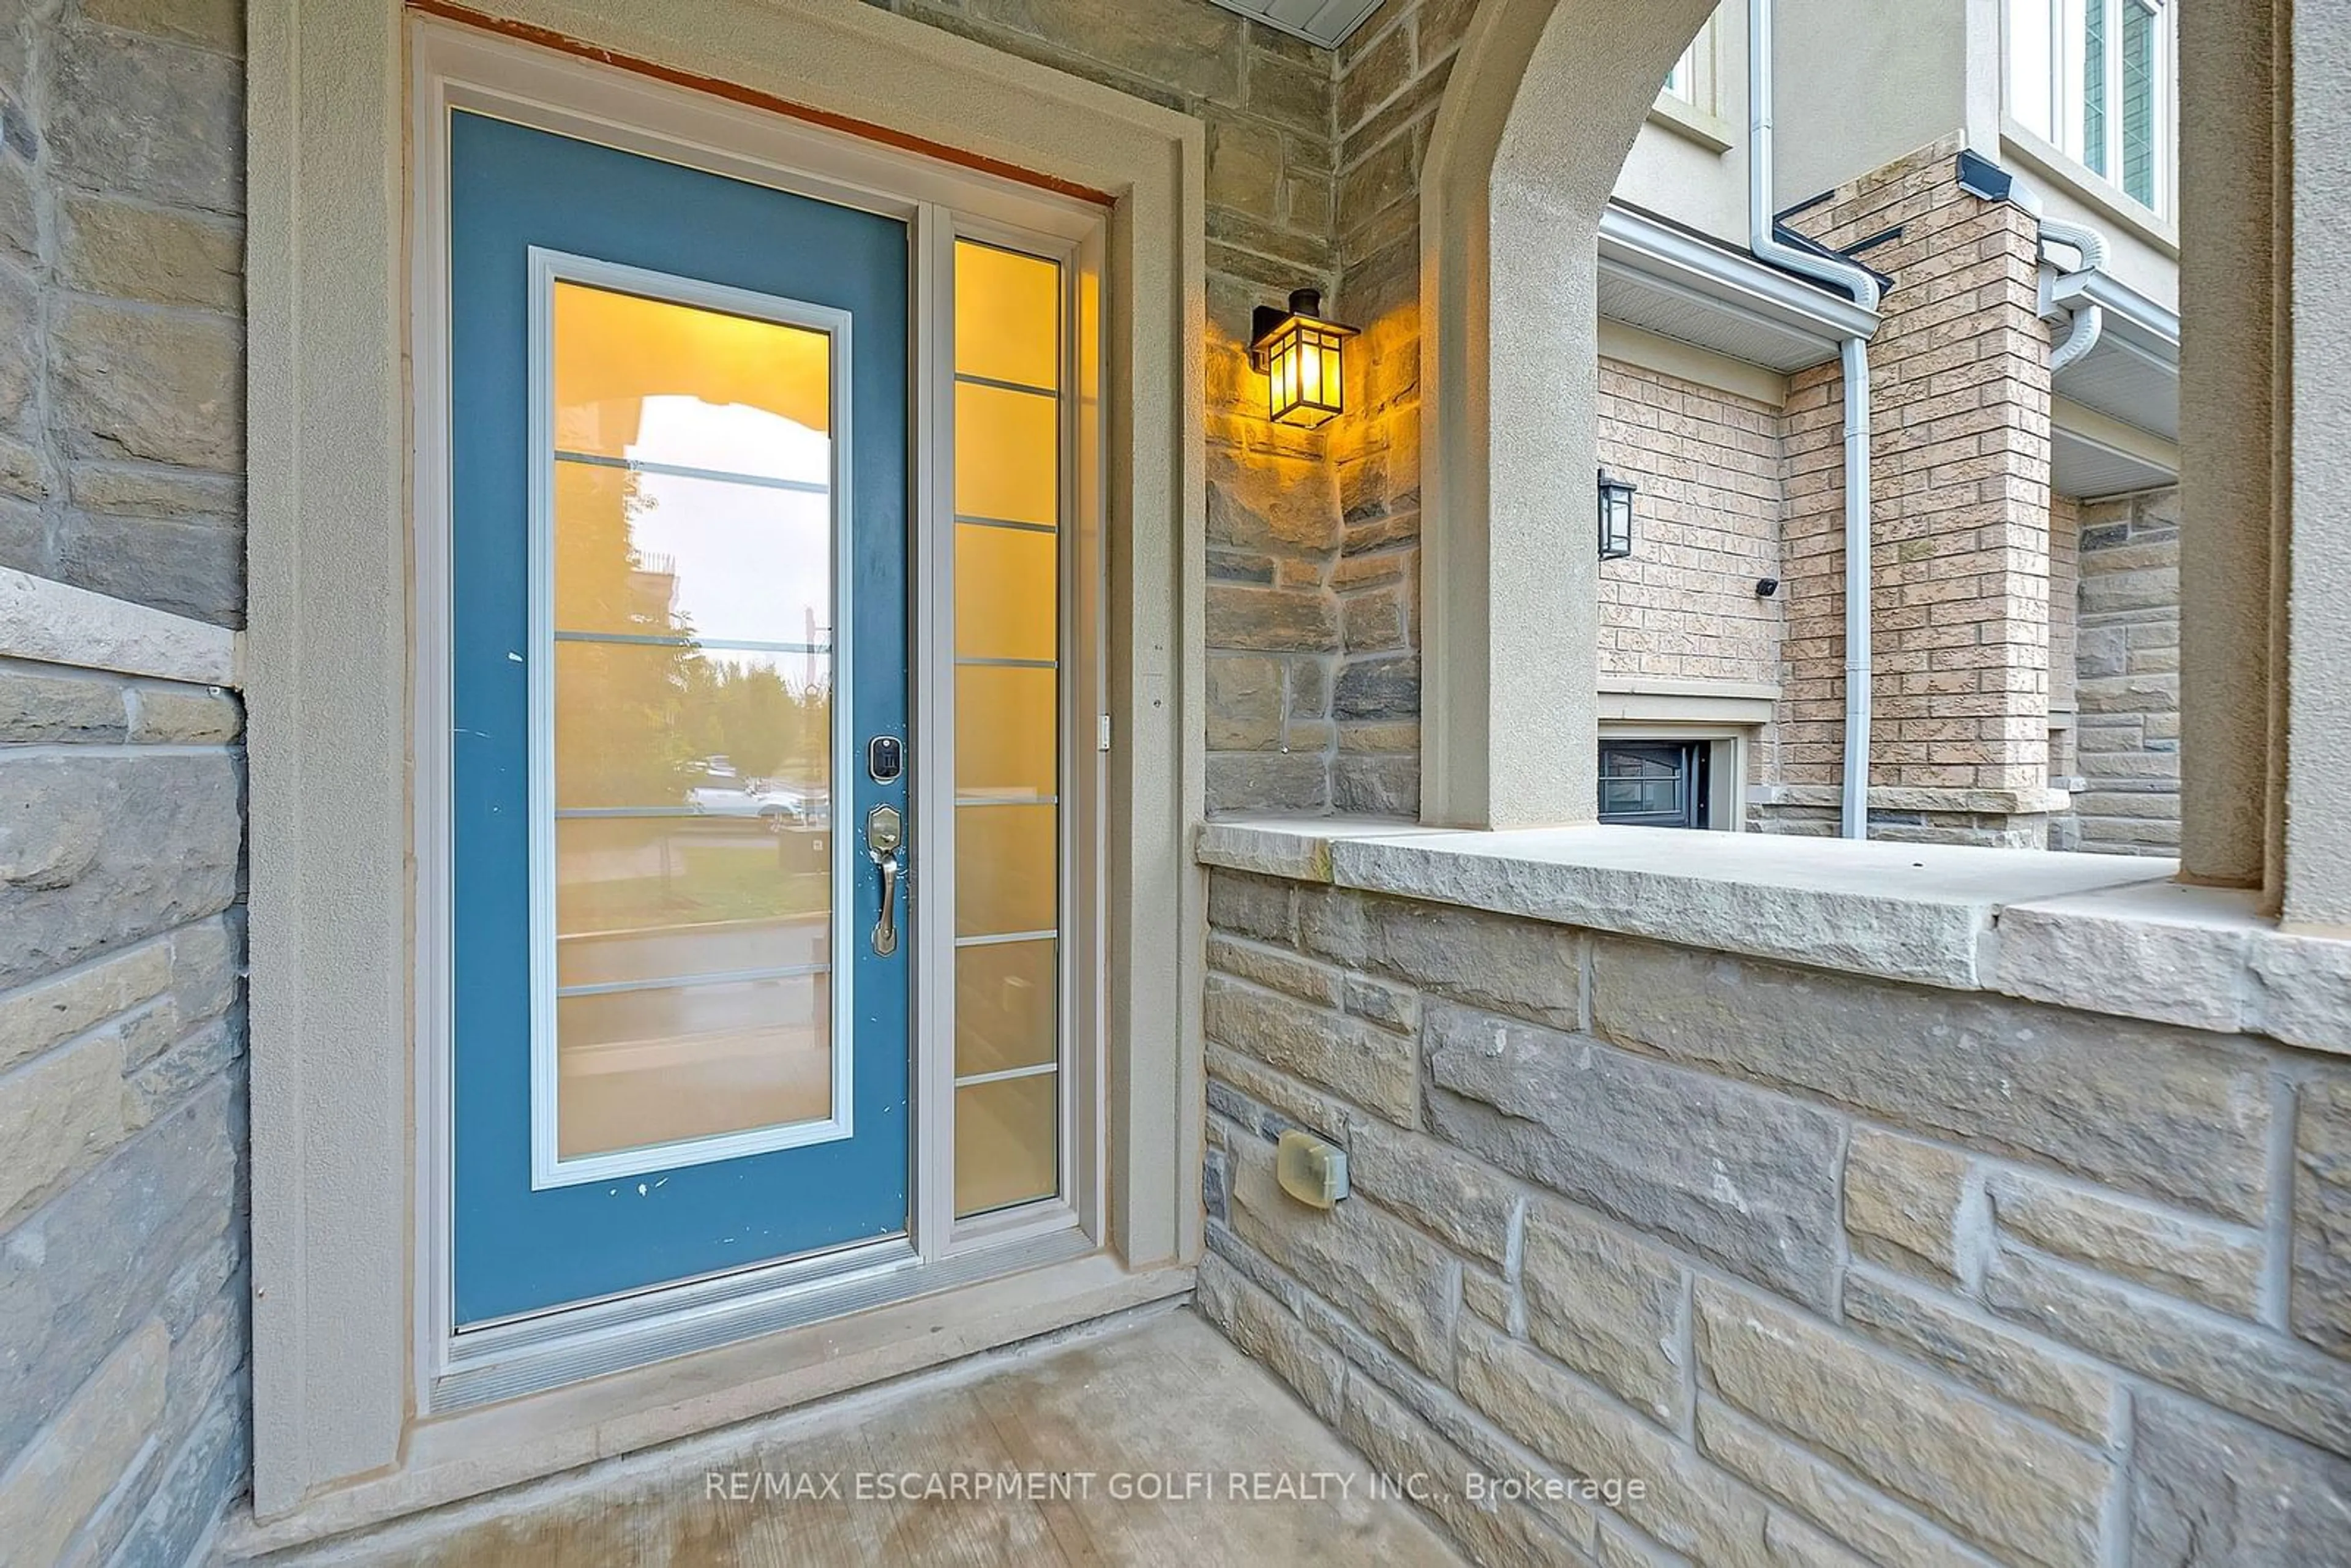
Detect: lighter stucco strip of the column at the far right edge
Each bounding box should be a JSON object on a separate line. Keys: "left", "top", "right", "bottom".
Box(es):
{"left": 2276, "top": 2, "right": 2351, "bottom": 926}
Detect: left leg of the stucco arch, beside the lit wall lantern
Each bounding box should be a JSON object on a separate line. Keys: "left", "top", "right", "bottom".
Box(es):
{"left": 1420, "top": 0, "right": 1714, "bottom": 828}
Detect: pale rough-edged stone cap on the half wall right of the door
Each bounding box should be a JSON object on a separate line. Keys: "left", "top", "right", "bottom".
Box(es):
{"left": 1197, "top": 816, "right": 2351, "bottom": 1056}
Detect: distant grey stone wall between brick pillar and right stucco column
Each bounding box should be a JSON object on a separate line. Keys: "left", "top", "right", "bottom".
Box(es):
{"left": 2074, "top": 489, "right": 2180, "bottom": 856}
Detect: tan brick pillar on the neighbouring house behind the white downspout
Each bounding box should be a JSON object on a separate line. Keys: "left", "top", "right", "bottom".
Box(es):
{"left": 1777, "top": 137, "right": 2050, "bottom": 846}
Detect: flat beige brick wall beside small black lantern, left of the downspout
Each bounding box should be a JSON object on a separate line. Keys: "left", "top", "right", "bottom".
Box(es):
{"left": 1599, "top": 359, "right": 1787, "bottom": 684}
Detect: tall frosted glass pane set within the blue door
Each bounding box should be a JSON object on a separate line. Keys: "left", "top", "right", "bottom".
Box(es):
{"left": 543, "top": 277, "right": 837, "bottom": 1171}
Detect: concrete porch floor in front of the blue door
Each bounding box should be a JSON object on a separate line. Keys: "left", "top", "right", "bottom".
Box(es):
{"left": 271, "top": 1310, "right": 1462, "bottom": 1568}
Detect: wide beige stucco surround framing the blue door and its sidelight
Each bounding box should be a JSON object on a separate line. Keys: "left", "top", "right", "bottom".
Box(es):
{"left": 247, "top": 0, "right": 1206, "bottom": 1545}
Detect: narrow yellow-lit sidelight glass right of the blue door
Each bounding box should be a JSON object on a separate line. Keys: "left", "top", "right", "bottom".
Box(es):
{"left": 954, "top": 240, "right": 1065, "bottom": 1218}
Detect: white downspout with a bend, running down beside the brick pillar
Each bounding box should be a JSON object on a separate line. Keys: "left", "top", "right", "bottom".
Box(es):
{"left": 1747, "top": 0, "right": 1878, "bottom": 839}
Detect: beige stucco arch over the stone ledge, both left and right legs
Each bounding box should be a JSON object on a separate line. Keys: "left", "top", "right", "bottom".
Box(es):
{"left": 1420, "top": 0, "right": 2351, "bottom": 929}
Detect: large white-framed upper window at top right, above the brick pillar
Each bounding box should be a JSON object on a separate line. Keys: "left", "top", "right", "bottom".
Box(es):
{"left": 2008, "top": 0, "right": 2177, "bottom": 212}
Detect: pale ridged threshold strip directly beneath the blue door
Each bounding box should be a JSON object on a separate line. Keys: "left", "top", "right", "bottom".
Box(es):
{"left": 428, "top": 1223, "right": 1095, "bottom": 1413}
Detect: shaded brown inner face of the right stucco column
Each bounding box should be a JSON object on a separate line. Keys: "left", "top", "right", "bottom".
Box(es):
{"left": 2180, "top": 5, "right": 2283, "bottom": 887}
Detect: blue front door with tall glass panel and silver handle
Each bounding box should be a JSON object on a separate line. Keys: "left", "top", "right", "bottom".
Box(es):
{"left": 449, "top": 113, "right": 910, "bottom": 1328}
